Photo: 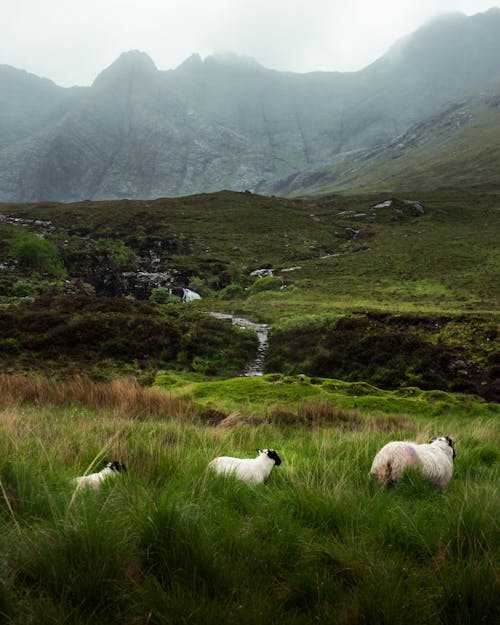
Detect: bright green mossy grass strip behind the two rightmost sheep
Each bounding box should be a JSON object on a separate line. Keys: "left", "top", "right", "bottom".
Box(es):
{"left": 155, "top": 372, "right": 500, "bottom": 425}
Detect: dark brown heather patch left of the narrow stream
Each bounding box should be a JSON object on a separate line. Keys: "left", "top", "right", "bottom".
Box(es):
{"left": 0, "top": 296, "right": 256, "bottom": 379}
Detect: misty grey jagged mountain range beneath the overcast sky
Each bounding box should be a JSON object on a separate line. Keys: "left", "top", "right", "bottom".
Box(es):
{"left": 0, "top": 9, "right": 500, "bottom": 202}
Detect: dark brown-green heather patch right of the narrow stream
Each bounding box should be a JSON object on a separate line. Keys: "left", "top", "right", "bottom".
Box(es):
{"left": 266, "top": 313, "right": 500, "bottom": 401}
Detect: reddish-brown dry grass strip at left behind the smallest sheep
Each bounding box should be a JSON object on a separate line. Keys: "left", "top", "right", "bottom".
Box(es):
{"left": 0, "top": 374, "right": 200, "bottom": 420}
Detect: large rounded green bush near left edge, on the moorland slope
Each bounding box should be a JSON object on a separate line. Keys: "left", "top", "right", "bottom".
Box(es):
{"left": 10, "top": 232, "right": 67, "bottom": 278}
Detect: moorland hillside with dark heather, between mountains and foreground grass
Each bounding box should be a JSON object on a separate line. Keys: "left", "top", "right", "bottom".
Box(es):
{"left": 0, "top": 187, "right": 500, "bottom": 399}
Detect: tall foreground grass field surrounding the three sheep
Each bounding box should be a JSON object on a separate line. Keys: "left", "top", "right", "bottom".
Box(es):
{"left": 0, "top": 376, "right": 500, "bottom": 625}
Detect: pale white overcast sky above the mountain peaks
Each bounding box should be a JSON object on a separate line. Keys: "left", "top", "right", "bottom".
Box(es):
{"left": 0, "top": 0, "right": 500, "bottom": 86}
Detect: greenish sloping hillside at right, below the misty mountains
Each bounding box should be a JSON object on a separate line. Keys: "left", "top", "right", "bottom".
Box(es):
{"left": 268, "top": 81, "right": 500, "bottom": 195}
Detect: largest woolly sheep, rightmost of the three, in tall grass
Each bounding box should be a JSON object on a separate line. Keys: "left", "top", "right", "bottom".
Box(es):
{"left": 370, "top": 436, "right": 456, "bottom": 489}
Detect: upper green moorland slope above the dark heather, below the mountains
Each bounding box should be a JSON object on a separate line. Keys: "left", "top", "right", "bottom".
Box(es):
{"left": 0, "top": 185, "right": 500, "bottom": 322}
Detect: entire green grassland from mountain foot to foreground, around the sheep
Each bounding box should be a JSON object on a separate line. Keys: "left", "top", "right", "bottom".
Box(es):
{"left": 0, "top": 185, "right": 500, "bottom": 625}
